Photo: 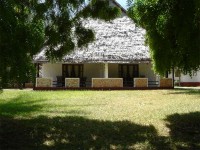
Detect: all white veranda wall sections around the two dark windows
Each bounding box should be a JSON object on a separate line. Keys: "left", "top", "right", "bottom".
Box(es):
{"left": 41, "top": 63, "right": 156, "bottom": 81}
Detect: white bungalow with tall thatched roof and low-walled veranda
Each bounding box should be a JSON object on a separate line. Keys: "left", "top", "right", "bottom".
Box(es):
{"left": 34, "top": 0, "right": 172, "bottom": 88}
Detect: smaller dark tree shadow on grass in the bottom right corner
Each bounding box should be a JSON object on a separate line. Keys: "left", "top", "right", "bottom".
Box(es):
{"left": 166, "top": 112, "right": 200, "bottom": 150}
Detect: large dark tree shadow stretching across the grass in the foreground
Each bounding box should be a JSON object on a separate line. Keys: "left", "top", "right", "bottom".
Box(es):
{"left": 0, "top": 116, "right": 170, "bottom": 150}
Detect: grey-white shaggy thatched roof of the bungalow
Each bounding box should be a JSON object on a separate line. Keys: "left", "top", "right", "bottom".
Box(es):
{"left": 34, "top": 2, "right": 150, "bottom": 63}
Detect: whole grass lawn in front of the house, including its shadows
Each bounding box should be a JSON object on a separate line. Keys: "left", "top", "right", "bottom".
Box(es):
{"left": 0, "top": 89, "right": 200, "bottom": 150}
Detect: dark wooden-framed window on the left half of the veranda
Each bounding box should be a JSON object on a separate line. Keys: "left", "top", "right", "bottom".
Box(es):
{"left": 62, "top": 64, "right": 83, "bottom": 78}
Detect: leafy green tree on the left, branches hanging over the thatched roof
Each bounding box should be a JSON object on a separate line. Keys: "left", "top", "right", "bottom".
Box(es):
{"left": 0, "top": 0, "right": 120, "bottom": 87}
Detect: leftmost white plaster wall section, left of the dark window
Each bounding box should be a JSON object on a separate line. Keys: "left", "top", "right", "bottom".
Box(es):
{"left": 41, "top": 63, "right": 62, "bottom": 80}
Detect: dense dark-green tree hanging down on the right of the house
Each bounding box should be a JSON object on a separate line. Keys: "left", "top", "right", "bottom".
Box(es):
{"left": 128, "top": 0, "right": 200, "bottom": 75}
